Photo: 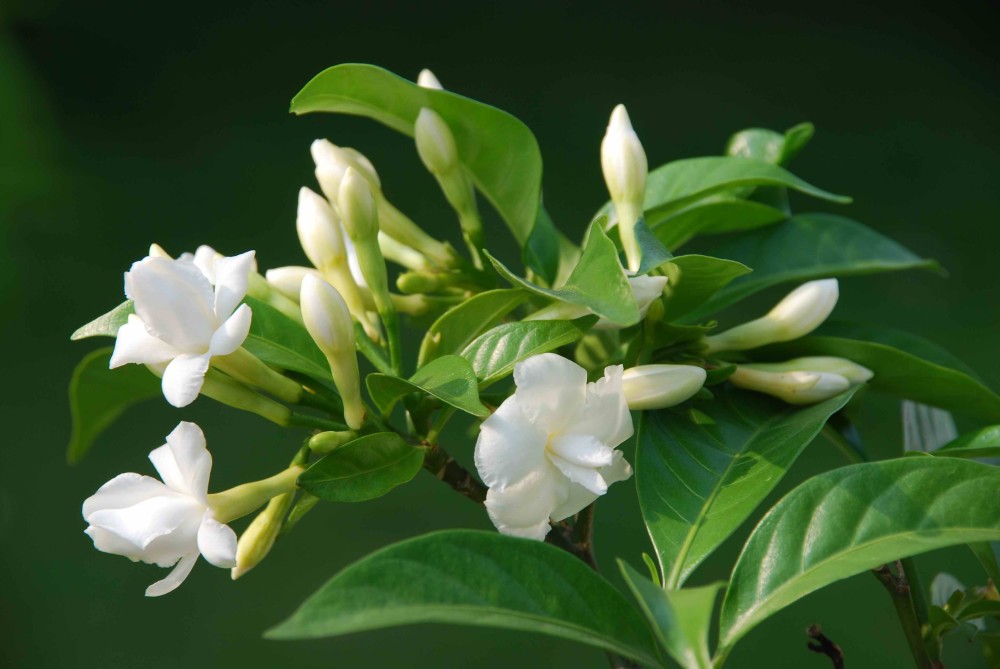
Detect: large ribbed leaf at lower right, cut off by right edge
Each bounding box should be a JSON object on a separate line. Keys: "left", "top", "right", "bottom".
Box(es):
{"left": 720, "top": 457, "right": 1000, "bottom": 649}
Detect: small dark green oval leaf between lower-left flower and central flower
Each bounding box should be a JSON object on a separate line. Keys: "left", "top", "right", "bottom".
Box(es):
{"left": 299, "top": 432, "right": 424, "bottom": 502}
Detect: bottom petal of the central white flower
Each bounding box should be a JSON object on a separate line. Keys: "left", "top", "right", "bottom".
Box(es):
{"left": 486, "top": 463, "right": 568, "bottom": 541}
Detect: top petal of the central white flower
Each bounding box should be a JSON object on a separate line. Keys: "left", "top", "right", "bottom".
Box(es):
{"left": 514, "top": 353, "right": 587, "bottom": 433}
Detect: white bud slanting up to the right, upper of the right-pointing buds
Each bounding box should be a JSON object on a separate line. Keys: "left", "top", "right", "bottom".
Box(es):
{"left": 705, "top": 279, "right": 840, "bottom": 353}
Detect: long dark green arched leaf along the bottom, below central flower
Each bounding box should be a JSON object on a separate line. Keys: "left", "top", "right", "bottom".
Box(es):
{"left": 267, "top": 530, "right": 662, "bottom": 667}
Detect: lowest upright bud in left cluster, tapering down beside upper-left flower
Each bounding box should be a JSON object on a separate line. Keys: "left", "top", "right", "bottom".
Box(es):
{"left": 299, "top": 275, "right": 365, "bottom": 430}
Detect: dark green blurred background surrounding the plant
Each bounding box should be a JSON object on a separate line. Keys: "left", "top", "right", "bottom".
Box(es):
{"left": 0, "top": 0, "right": 1000, "bottom": 669}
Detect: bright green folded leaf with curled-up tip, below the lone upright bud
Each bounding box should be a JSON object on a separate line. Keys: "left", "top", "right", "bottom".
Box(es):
{"left": 486, "top": 221, "right": 639, "bottom": 326}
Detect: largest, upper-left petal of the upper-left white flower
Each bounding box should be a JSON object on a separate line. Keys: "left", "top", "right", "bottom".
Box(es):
{"left": 125, "top": 258, "right": 216, "bottom": 353}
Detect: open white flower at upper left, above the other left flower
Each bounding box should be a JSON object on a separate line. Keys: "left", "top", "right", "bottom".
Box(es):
{"left": 111, "top": 251, "right": 254, "bottom": 407}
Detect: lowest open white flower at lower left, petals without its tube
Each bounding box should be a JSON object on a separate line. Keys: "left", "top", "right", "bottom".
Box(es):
{"left": 83, "top": 423, "right": 236, "bottom": 597}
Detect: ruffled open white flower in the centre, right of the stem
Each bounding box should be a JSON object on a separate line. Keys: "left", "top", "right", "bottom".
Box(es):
{"left": 476, "top": 353, "right": 632, "bottom": 540}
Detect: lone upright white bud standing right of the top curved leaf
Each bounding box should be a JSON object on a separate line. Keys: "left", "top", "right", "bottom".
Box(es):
{"left": 601, "top": 105, "right": 649, "bottom": 271}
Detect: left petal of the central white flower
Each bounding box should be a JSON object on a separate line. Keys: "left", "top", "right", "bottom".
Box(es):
{"left": 475, "top": 396, "right": 546, "bottom": 488}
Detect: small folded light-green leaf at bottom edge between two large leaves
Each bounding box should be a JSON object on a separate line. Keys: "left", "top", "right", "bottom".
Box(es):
{"left": 618, "top": 560, "right": 723, "bottom": 669}
